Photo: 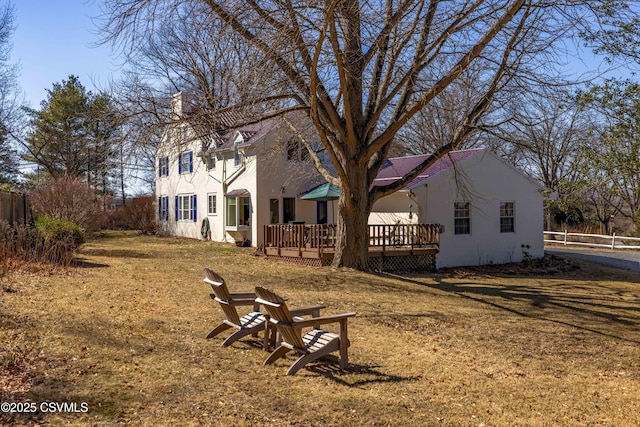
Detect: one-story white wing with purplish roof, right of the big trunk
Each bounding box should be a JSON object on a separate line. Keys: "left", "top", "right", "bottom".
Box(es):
{"left": 369, "top": 149, "right": 544, "bottom": 268}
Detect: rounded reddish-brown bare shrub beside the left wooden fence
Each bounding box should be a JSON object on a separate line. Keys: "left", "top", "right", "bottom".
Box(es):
{"left": 29, "top": 176, "right": 105, "bottom": 233}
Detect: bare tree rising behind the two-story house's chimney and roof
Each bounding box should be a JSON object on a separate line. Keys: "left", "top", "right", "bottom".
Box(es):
{"left": 102, "top": 1, "right": 280, "bottom": 195}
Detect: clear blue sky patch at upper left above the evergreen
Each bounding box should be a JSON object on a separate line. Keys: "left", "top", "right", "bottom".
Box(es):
{"left": 10, "top": 0, "right": 119, "bottom": 108}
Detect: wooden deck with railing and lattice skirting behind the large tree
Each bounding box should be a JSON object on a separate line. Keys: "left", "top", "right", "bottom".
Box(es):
{"left": 263, "top": 224, "right": 440, "bottom": 265}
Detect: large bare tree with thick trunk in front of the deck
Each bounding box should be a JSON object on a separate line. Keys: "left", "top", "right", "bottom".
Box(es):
{"left": 100, "top": 0, "right": 608, "bottom": 269}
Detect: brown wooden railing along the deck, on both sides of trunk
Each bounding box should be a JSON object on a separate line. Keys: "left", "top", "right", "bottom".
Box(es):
{"left": 264, "top": 224, "right": 440, "bottom": 253}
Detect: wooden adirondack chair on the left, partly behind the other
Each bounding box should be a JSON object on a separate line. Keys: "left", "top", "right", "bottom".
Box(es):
{"left": 204, "top": 268, "right": 269, "bottom": 351}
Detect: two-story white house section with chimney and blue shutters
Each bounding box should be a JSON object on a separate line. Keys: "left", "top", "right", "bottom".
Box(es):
{"left": 156, "top": 93, "right": 331, "bottom": 246}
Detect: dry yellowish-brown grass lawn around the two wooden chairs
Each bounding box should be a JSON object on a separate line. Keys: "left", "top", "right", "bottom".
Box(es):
{"left": 0, "top": 233, "right": 640, "bottom": 426}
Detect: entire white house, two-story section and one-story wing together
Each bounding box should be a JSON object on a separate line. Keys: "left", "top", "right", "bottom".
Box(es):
{"left": 156, "top": 94, "right": 544, "bottom": 268}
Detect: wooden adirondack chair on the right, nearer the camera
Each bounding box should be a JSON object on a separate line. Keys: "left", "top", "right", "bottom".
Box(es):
{"left": 256, "top": 286, "right": 356, "bottom": 375}
